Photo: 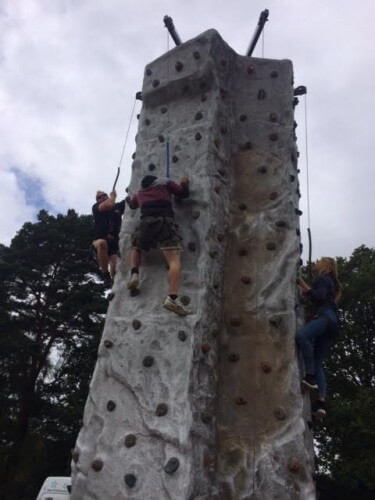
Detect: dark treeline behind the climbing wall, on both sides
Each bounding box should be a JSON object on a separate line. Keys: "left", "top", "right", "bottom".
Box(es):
{"left": 0, "top": 210, "right": 375, "bottom": 500}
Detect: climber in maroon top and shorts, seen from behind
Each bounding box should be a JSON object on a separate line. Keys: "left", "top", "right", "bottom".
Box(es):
{"left": 126, "top": 175, "right": 191, "bottom": 316}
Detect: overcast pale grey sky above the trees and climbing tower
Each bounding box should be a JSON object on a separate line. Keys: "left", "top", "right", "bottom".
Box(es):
{"left": 0, "top": 0, "right": 375, "bottom": 258}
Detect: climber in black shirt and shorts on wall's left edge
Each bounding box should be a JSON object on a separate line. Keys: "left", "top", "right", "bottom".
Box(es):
{"left": 92, "top": 191, "right": 125, "bottom": 281}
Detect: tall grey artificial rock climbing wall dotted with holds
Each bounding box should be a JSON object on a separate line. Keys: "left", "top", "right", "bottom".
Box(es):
{"left": 72, "top": 30, "right": 314, "bottom": 500}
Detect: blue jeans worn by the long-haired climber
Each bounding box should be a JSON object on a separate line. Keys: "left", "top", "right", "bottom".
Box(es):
{"left": 296, "top": 309, "right": 338, "bottom": 397}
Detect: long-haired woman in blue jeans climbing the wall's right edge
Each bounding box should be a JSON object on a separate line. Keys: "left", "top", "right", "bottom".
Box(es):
{"left": 296, "top": 257, "right": 341, "bottom": 418}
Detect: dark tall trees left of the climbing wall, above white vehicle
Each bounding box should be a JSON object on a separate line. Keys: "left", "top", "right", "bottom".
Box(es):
{"left": 0, "top": 210, "right": 106, "bottom": 500}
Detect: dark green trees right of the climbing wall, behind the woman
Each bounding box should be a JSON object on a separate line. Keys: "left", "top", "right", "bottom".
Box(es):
{"left": 315, "top": 246, "right": 375, "bottom": 500}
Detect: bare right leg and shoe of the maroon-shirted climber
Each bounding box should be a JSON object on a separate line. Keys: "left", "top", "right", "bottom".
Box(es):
{"left": 163, "top": 249, "right": 191, "bottom": 316}
